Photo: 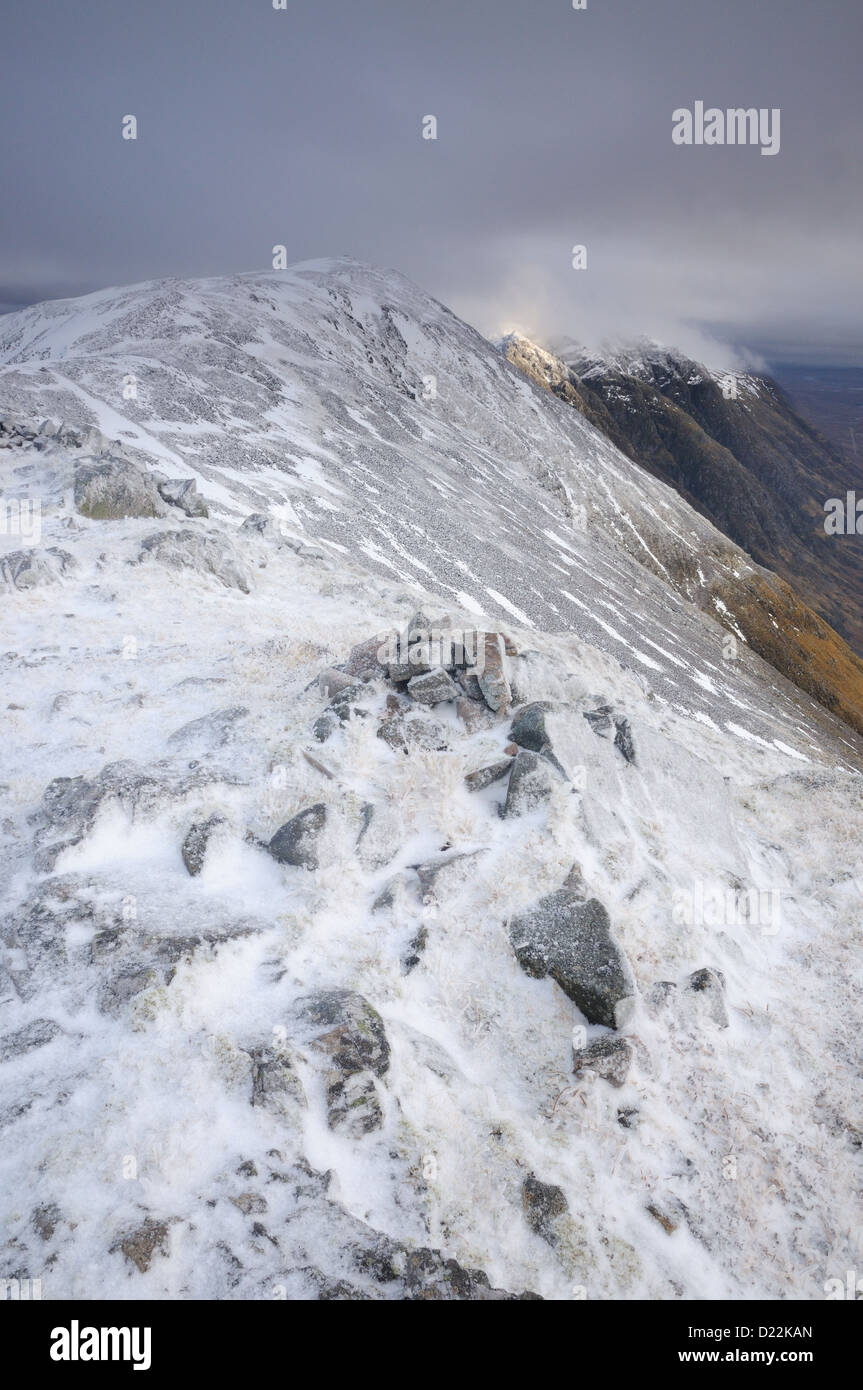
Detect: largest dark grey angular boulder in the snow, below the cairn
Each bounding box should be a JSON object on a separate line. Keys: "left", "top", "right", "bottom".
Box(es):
{"left": 510, "top": 888, "right": 635, "bottom": 1029}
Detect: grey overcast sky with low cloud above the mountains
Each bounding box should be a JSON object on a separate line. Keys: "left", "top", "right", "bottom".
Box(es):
{"left": 0, "top": 0, "right": 863, "bottom": 364}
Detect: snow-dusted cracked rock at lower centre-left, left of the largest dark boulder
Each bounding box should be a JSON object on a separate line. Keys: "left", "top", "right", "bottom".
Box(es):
{"left": 295, "top": 990, "right": 389, "bottom": 1137}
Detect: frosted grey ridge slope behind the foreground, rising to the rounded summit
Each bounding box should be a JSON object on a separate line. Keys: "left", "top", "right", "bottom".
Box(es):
{"left": 0, "top": 261, "right": 863, "bottom": 742}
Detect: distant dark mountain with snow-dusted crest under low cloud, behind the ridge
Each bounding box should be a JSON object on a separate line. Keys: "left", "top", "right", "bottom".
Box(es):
{"left": 507, "top": 338, "right": 863, "bottom": 652}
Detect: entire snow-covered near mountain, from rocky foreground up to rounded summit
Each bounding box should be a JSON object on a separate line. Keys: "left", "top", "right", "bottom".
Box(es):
{"left": 0, "top": 261, "right": 863, "bottom": 1298}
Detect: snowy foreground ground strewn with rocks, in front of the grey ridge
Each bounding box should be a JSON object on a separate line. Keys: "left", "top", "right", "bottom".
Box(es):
{"left": 0, "top": 432, "right": 863, "bottom": 1300}
